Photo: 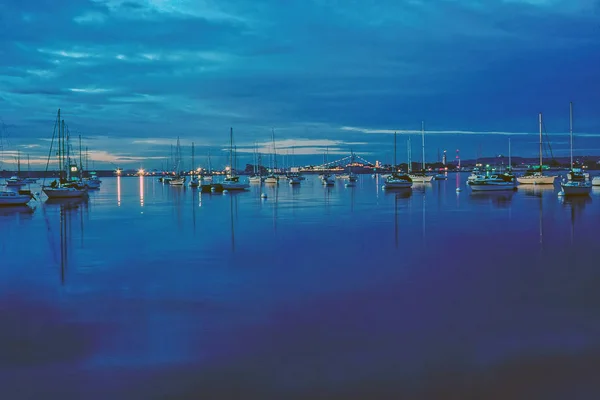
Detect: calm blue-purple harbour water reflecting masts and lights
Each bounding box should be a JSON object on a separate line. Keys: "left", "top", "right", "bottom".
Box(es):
{"left": 0, "top": 175, "right": 600, "bottom": 399}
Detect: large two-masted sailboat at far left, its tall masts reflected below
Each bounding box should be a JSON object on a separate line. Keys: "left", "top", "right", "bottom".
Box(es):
{"left": 42, "top": 109, "right": 88, "bottom": 199}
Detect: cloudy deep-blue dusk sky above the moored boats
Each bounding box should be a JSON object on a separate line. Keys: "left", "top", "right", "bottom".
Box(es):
{"left": 0, "top": 0, "right": 600, "bottom": 169}
